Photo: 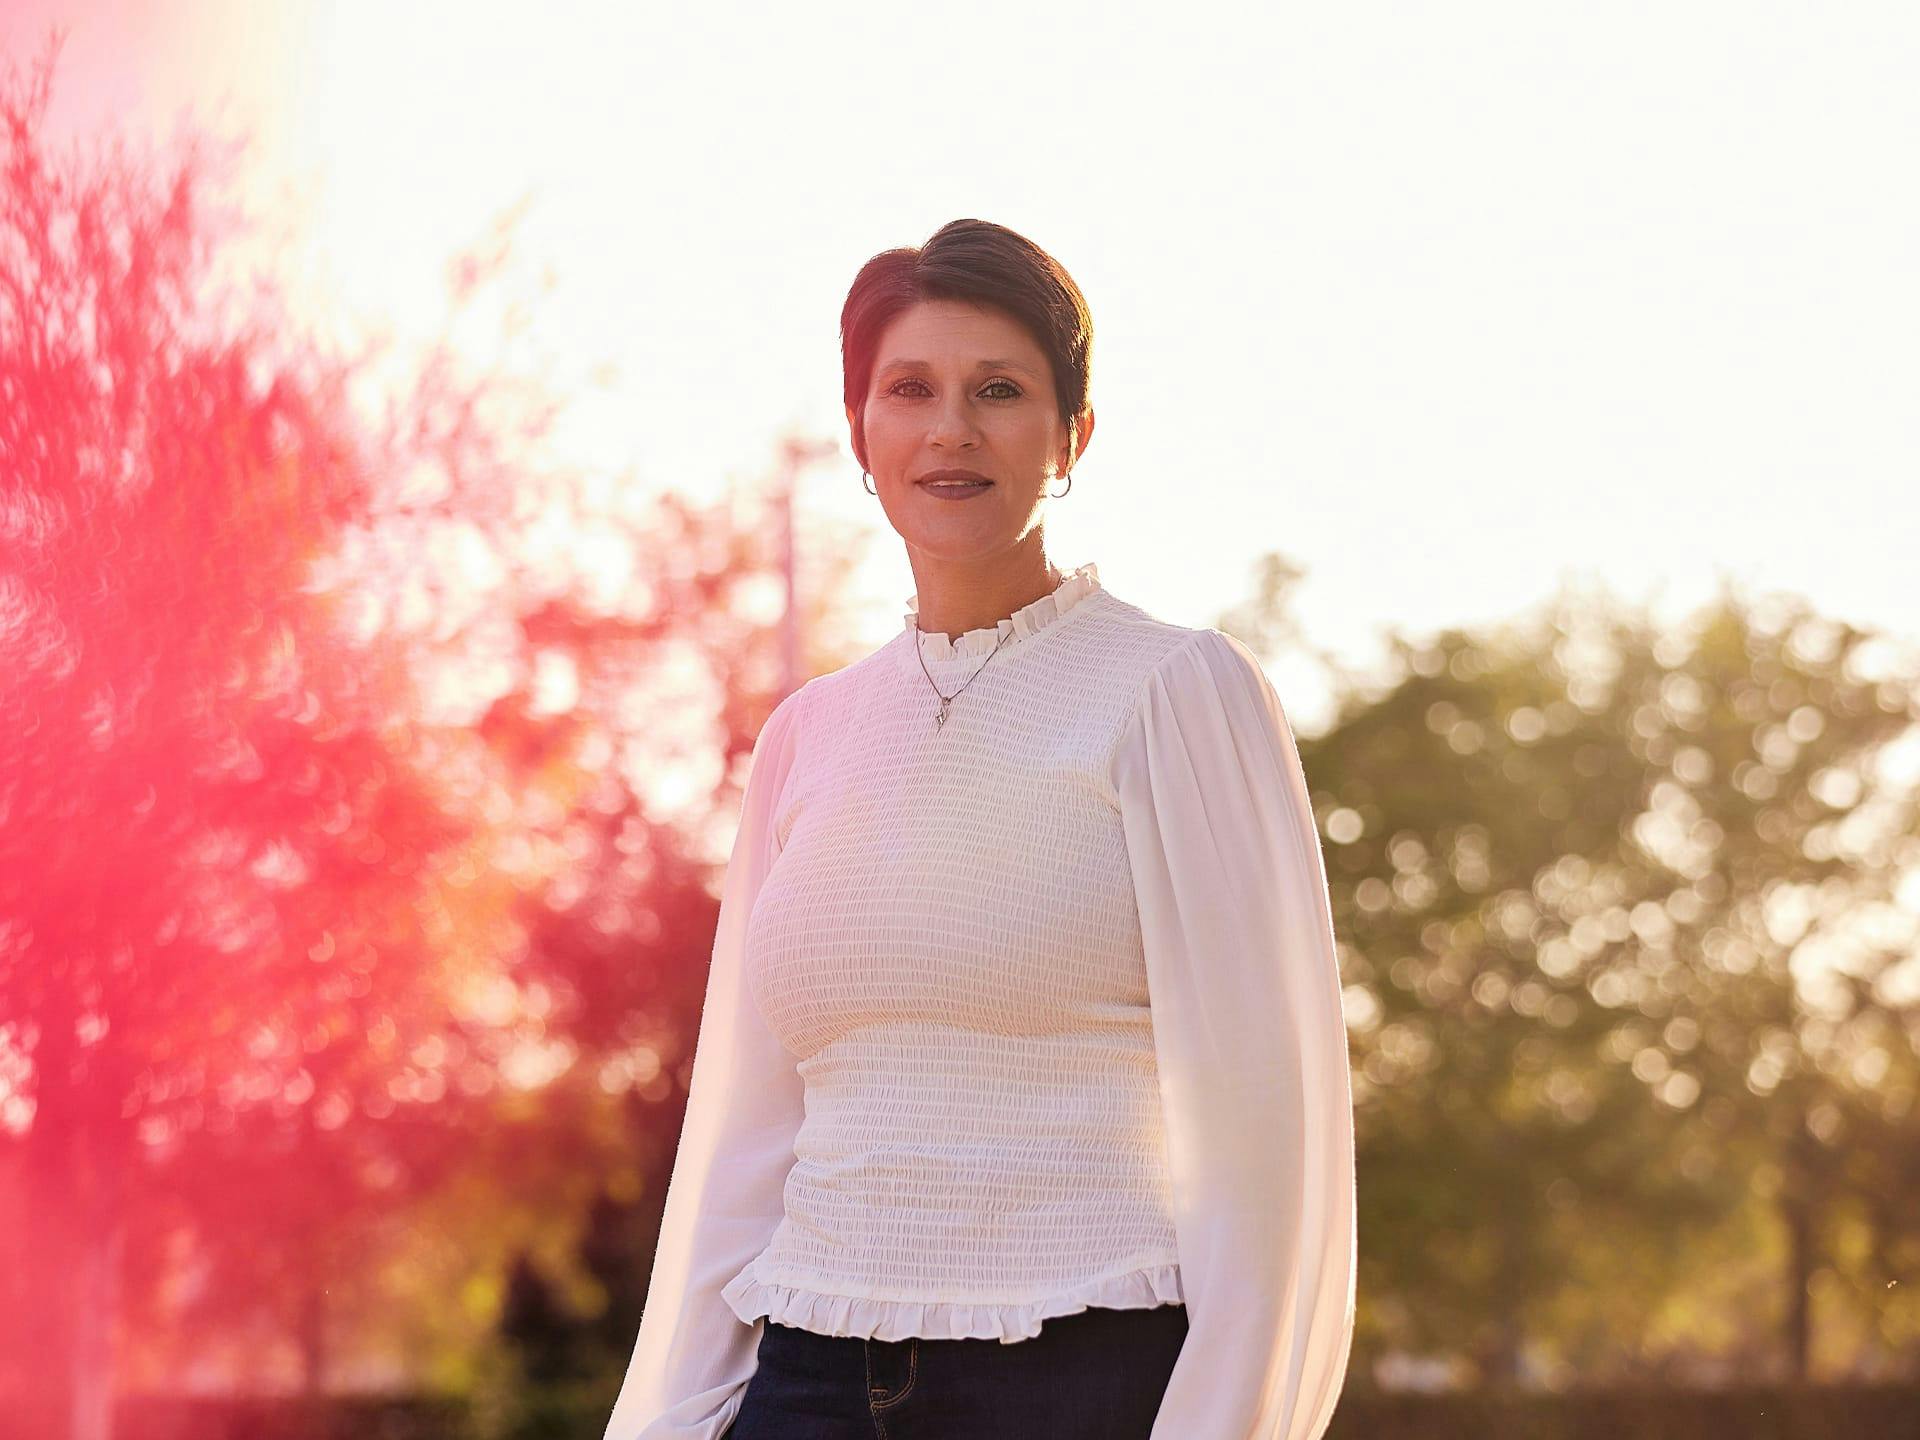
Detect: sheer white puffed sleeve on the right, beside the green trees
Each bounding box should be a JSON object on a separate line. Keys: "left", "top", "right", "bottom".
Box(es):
{"left": 1112, "top": 630, "right": 1357, "bottom": 1440}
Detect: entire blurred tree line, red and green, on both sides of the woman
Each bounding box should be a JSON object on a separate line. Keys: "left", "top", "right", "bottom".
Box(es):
{"left": 0, "top": 14, "right": 1920, "bottom": 1440}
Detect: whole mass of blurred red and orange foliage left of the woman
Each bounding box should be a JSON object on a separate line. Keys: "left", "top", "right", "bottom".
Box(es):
{"left": 0, "top": 30, "right": 867, "bottom": 1440}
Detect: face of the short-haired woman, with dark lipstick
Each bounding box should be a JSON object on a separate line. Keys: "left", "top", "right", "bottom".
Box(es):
{"left": 847, "top": 300, "right": 1092, "bottom": 561}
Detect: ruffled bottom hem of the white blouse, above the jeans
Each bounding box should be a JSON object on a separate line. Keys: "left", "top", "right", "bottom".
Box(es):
{"left": 720, "top": 1261, "right": 1187, "bottom": 1344}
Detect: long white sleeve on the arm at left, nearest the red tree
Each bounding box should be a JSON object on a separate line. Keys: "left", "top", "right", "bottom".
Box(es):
{"left": 605, "top": 691, "right": 804, "bottom": 1440}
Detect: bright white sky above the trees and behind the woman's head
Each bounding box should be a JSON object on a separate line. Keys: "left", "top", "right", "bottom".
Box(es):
{"left": 0, "top": 0, "right": 1920, "bottom": 730}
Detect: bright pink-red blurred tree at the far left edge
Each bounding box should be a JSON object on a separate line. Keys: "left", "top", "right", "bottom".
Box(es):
{"left": 0, "top": 36, "right": 476, "bottom": 1440}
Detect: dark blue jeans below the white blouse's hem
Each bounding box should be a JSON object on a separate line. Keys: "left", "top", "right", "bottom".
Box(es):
{"left": 722, "top": 1306, "right": 1187, "bottom": 1440}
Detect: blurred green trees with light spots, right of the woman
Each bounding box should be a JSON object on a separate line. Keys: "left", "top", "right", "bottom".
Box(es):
{"left": 1228, "top": 568, "right": 1920, "bottom": 1382}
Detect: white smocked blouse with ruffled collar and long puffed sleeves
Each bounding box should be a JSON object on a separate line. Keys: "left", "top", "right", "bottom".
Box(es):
{"left": 607, "top": 563, "right": 1357, "bottom": 1440}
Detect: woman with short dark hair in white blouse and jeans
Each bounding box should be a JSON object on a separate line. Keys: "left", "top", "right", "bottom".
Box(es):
{"left": 607, "top": 221, "right": 1356, "bottom": 1440}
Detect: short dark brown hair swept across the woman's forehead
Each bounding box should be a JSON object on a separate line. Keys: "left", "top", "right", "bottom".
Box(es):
{"left": 841, "top": 221, "right": 1092, "bottom": 470}
